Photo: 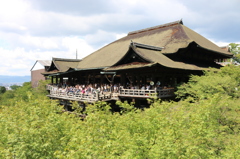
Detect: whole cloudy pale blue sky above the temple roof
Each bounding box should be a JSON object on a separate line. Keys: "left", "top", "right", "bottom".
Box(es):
{"left": 0, "top": 0, "right": 240, "bottom": 76}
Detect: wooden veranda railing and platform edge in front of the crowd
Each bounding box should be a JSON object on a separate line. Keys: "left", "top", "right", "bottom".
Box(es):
{"left": 47, "top": 85, "right": 175, "bottom": 103}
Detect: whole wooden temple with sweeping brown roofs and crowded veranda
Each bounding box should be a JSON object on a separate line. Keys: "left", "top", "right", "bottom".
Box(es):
{"left": 43, "top": 20, "right": 233, "bottom": 106}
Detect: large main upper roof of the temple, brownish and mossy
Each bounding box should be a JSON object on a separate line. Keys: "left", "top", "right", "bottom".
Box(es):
{"left": 77, "top": 20, "right": 232, "bottom": 69}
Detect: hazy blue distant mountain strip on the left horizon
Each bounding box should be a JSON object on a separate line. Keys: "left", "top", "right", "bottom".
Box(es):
{"left": 0, "top": 75, "right": 31, "bottom": 84}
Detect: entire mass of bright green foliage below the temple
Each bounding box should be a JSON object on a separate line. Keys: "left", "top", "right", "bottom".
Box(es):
{"left": 0, "top": 67, "right": 240, "bottom": 159}
